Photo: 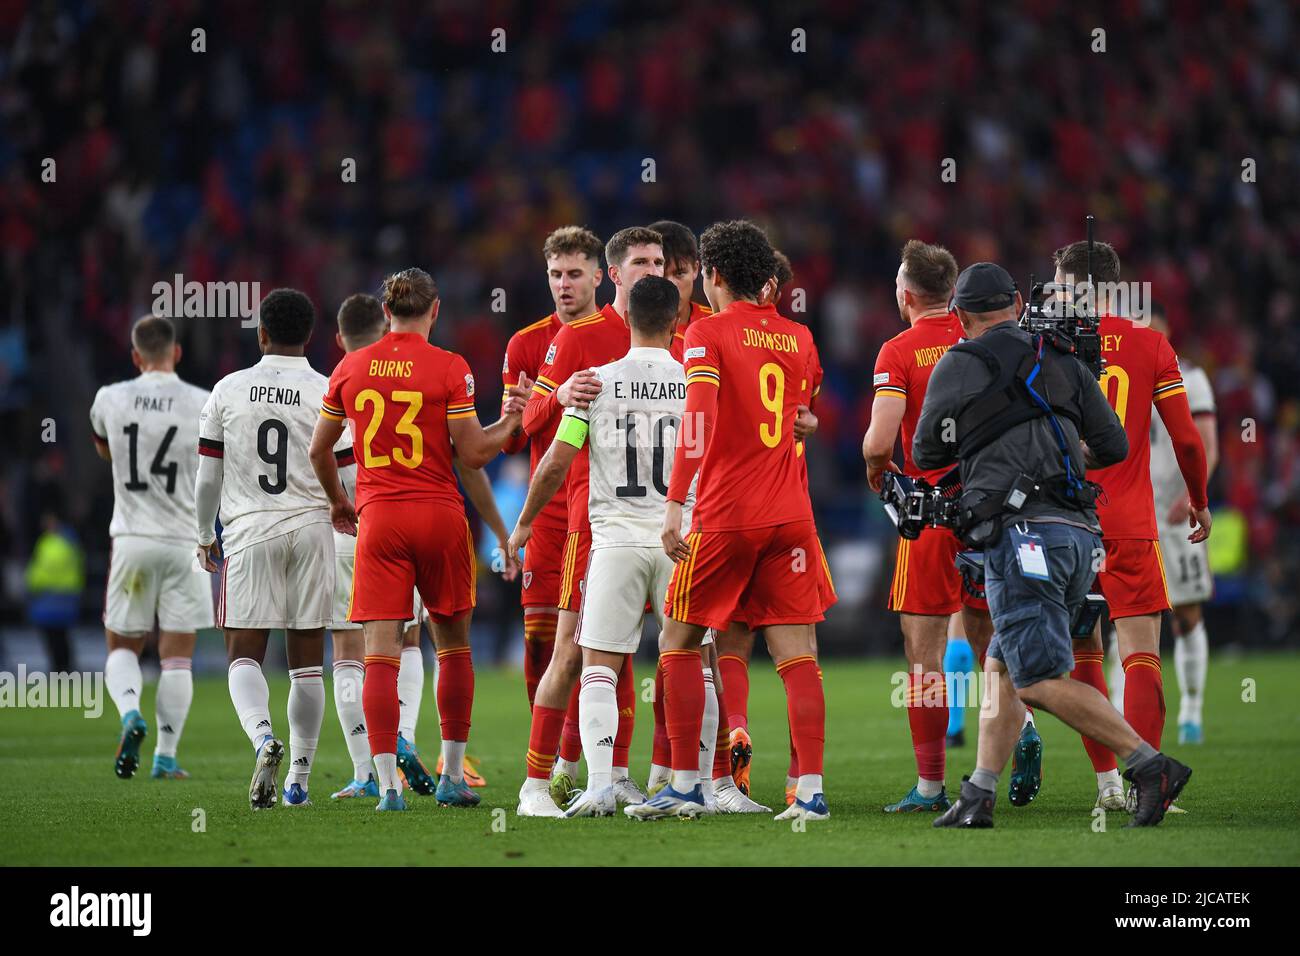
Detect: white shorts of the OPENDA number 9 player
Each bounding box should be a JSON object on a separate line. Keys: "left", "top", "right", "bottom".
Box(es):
{"left": 217, "top": 523, "right": 334, "bottom": 630}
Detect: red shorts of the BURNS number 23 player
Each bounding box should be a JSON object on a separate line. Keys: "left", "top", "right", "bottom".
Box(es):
{"left": 348, "top": 501, "right": 475, "bottom": 622}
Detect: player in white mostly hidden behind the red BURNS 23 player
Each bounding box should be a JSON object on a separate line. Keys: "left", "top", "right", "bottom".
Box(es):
{"left": 330, "top": 293, "right": 517, "bottom": 800}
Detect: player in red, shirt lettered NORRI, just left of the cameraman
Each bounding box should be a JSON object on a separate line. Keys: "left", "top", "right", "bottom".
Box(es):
{"left": 862, "top": 239, "right": 1003, "bottom": 813}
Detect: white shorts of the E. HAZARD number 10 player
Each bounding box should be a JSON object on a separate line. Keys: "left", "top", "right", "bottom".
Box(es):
{"left": 577, "top": 548, "right": 673, "bottom": 654}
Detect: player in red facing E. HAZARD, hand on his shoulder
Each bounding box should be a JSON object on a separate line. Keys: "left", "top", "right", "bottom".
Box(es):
{"left": 517, "top": 226, "right": 665, "bottom": 817}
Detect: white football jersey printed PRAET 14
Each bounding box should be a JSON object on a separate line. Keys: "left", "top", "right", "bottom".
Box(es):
{"left": 90, "top": 372, "right": 208, "bottom": 542}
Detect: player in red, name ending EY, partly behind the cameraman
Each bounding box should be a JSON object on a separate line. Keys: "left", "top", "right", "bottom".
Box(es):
{"left": 1054, "top": 242, "right": 1210, "bottom": 809}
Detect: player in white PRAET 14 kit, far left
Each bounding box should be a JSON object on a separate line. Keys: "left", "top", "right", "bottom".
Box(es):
{"left": 90, "top": 316, "right": 213, "bottom": 779}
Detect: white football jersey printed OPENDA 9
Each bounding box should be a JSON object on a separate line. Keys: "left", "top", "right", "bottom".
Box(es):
{"left": 199, "top": 355, "right": 351, "bottom": 554}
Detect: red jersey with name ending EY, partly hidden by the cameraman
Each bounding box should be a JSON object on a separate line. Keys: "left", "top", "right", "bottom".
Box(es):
{"left": 1088, "top": 316, "right": 1187, "bottom": 540}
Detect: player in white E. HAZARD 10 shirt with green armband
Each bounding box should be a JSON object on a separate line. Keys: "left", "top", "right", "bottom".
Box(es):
{"left": 507, "top": 276, "right": 746, "bottom": 817}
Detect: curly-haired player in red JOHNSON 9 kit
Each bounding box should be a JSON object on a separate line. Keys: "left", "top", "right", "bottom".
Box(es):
{"left": 634, "top": 221, "right": 829, "bottom": 819}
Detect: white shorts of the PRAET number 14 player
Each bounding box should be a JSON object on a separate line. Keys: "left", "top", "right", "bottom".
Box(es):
{"left": 104, "top": 535, "right": 215, "bottom": 636}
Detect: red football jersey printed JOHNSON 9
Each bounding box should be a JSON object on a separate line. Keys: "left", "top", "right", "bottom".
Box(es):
{"left": 668, "top": 302, "right": 813, "bottom": 531}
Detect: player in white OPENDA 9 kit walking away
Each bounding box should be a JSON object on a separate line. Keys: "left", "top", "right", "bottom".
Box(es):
{"left": 195, "top": 289, "right": 350, "bottom": 810}
